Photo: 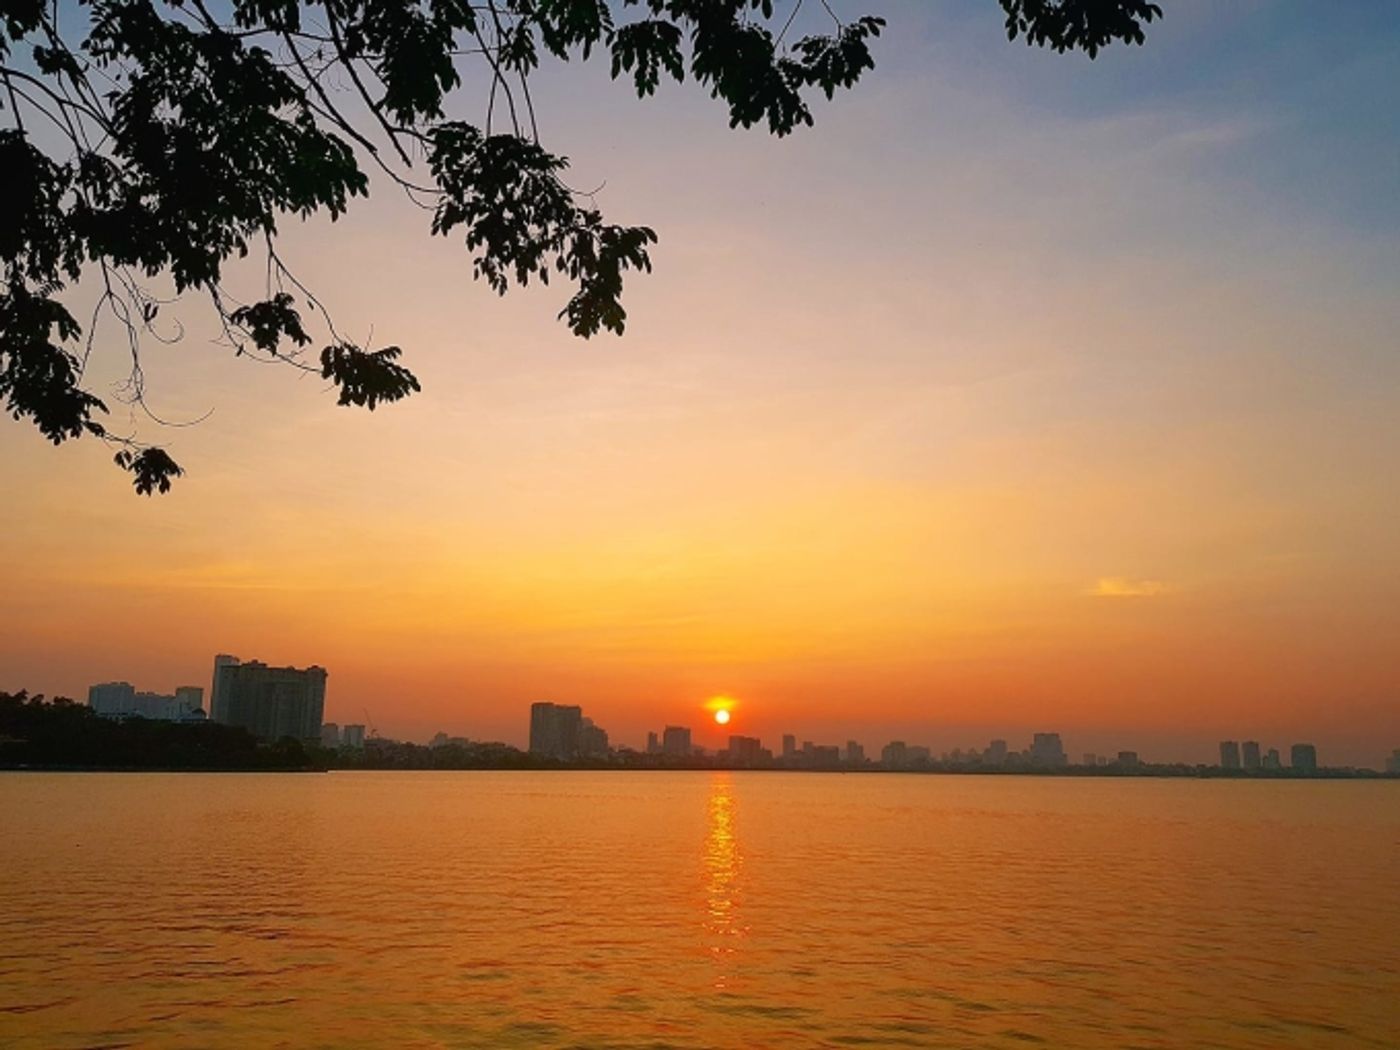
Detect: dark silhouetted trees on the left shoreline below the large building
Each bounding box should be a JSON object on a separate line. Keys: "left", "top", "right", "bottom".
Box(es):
{"left": 0, "top": 690, "right": 316, "bottom": 770}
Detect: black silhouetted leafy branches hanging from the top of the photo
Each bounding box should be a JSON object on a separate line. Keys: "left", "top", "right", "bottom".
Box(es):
{"left": 0, "top": 0, "right": 1161, "bottom": 494}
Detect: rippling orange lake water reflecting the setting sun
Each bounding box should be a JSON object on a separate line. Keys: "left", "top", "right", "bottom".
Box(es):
{"left": 0, "top": 773, "right": 1400, "bottom": 1050}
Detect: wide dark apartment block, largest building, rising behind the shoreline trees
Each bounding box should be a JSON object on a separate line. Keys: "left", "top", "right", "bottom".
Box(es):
{"left": 210, "top": 654, "right": 326, "bottom": 743}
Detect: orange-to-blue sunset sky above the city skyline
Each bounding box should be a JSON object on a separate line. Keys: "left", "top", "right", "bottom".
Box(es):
{"left": 0, "top": 0, "right": 1400, "bottom": 766}
